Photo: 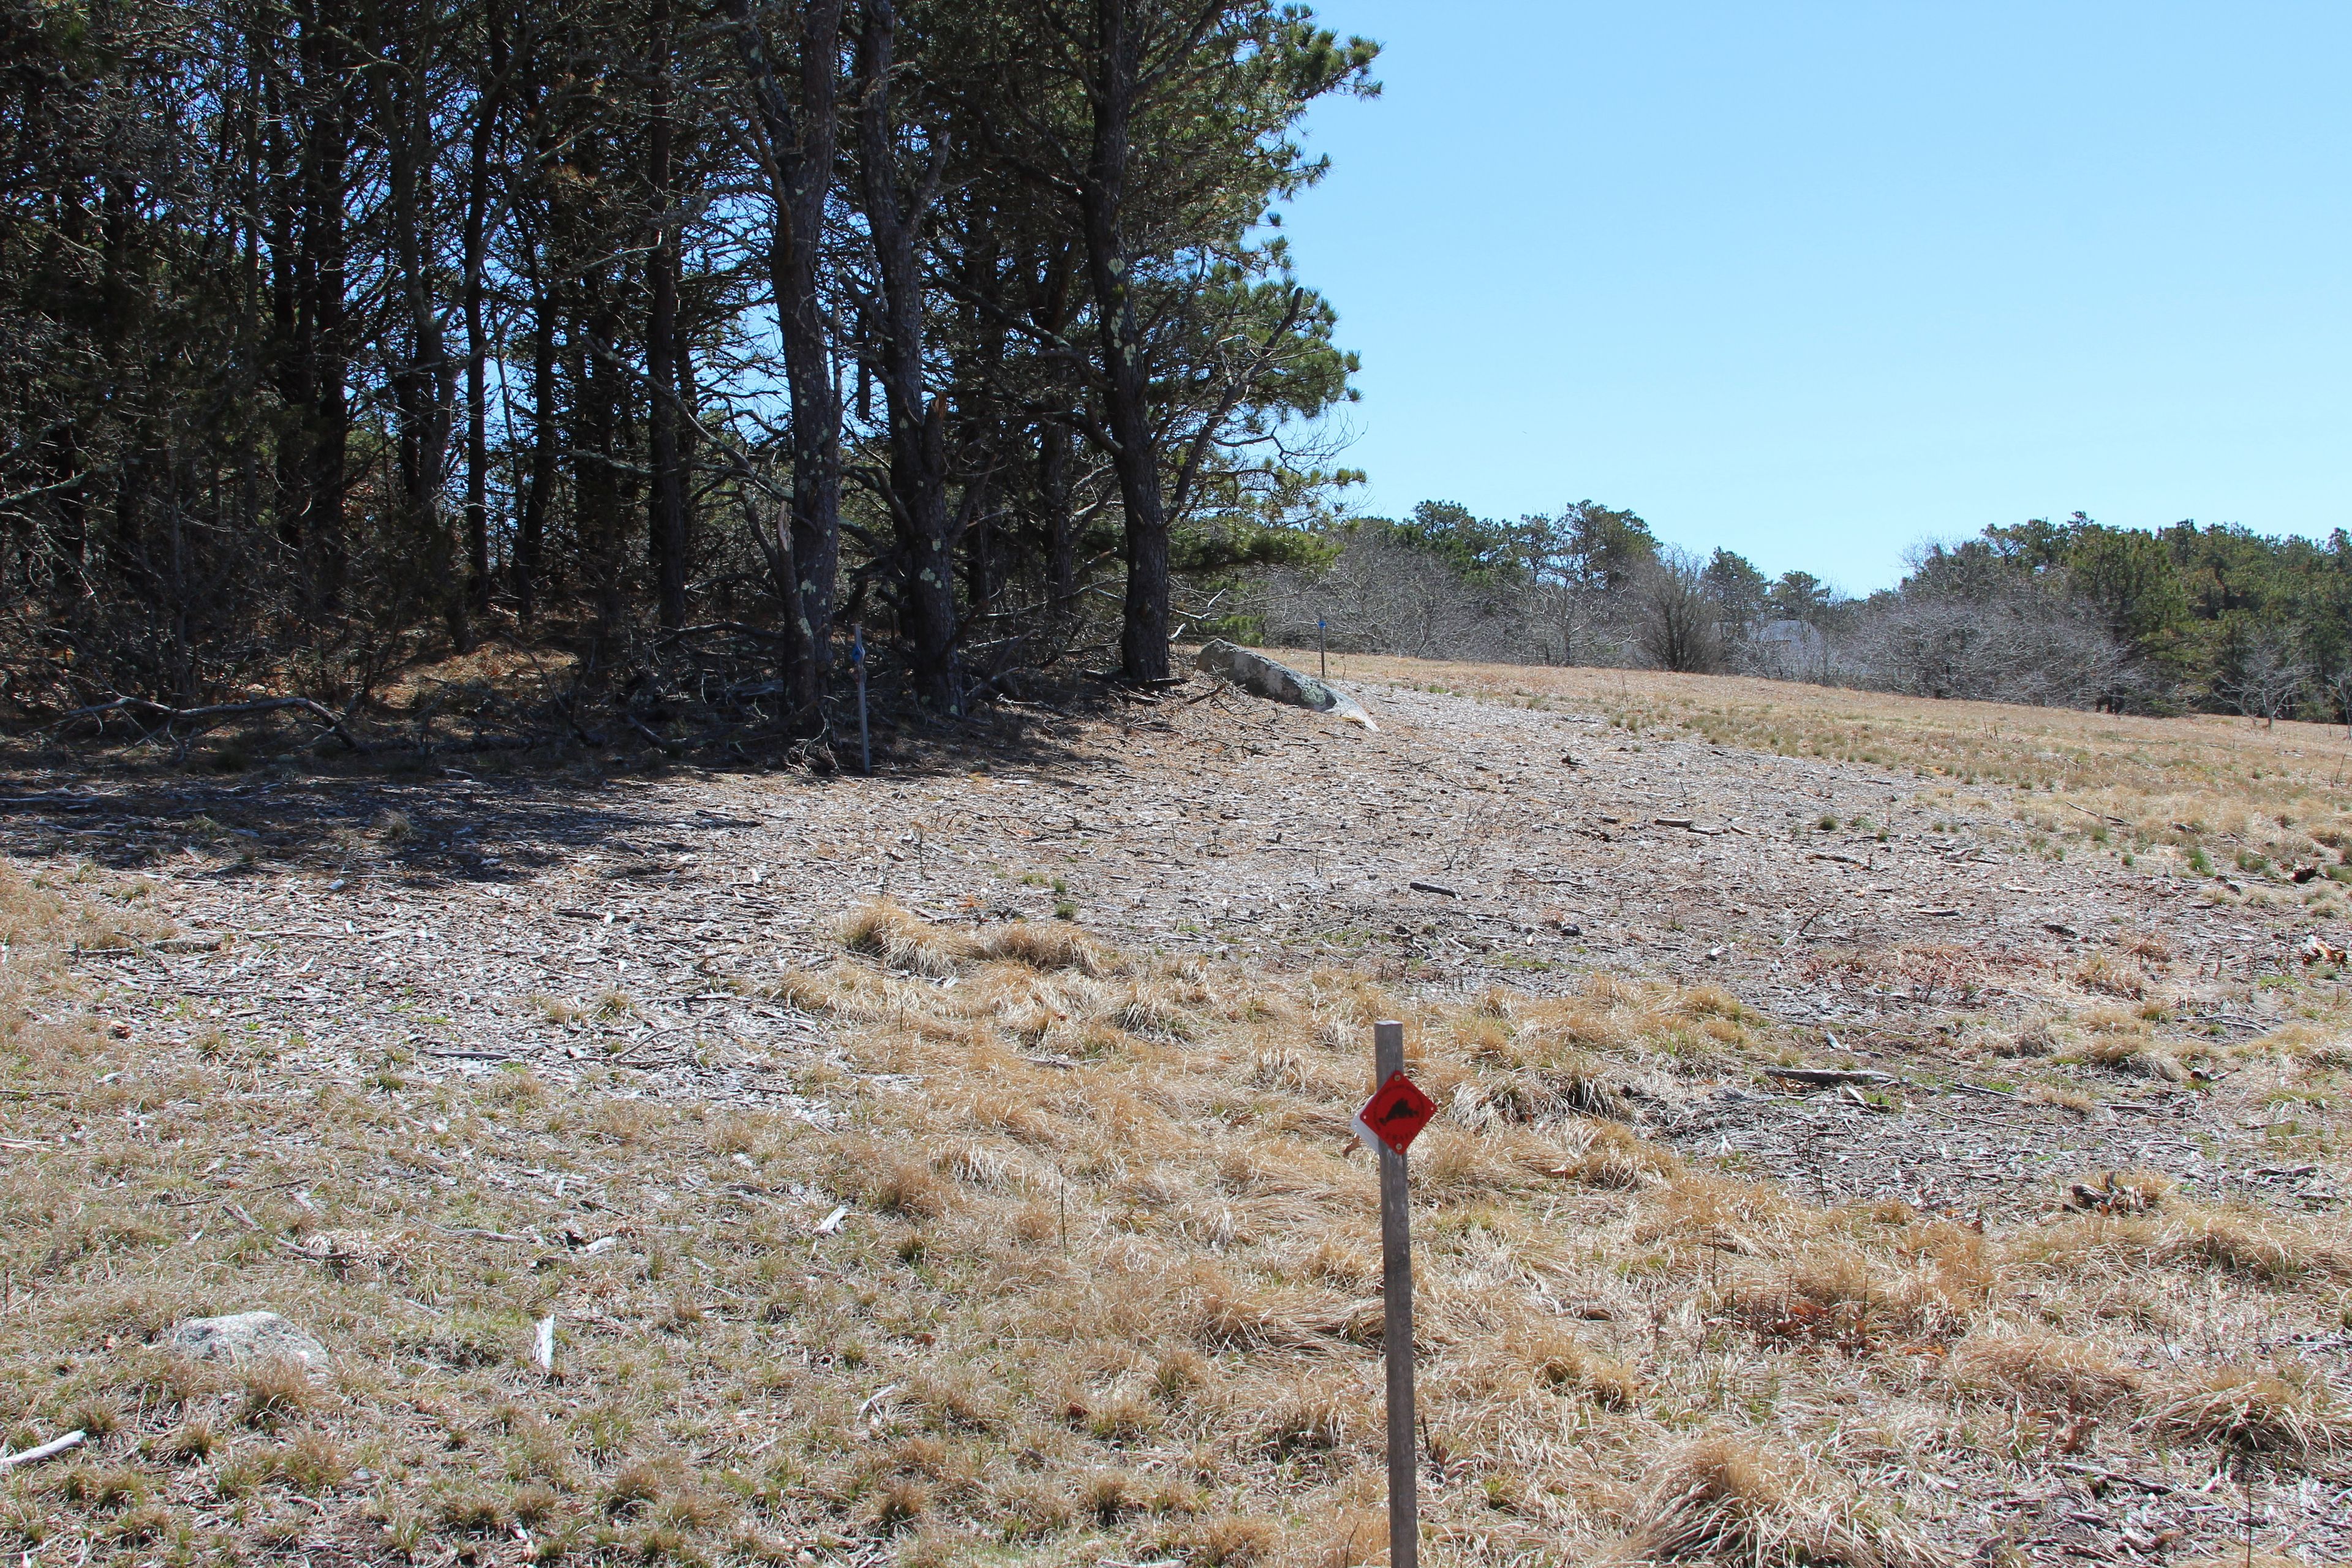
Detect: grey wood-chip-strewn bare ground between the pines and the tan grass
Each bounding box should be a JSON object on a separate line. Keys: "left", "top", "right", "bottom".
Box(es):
{"left": 0, "top": 668, "right": 2343, "bottom": 1213}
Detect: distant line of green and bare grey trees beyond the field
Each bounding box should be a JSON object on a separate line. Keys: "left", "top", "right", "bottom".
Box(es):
{"left": 1230, "top": 501, "right": 2352, "bottom": 722}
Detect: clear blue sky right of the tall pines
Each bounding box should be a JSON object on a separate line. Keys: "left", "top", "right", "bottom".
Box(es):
{"left": 1284, "top": 0, "right": 2352, "bottom": 592}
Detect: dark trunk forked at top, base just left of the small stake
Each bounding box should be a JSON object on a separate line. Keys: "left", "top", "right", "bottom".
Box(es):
{"left": 727, "top": 0, "right": 842, "bottom": 733}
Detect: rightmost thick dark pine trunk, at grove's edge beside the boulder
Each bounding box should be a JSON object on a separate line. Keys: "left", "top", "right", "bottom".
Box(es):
{"left": 1080, "top": 0, "right": 1169, "bottom": 682}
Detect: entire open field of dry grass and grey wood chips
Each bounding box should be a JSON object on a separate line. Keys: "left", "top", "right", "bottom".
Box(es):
{"left": 0, "top": 656, "right": 2352, "bottom": 1568}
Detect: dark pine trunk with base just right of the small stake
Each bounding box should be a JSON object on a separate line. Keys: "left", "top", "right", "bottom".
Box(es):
{"left": 859, "top": 0, "right": 955, "bottom": 710}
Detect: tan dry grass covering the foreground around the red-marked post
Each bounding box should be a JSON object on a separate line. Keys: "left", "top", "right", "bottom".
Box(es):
{"left": 0, "top": 860, "right": 2347, "bottom": 1568}
